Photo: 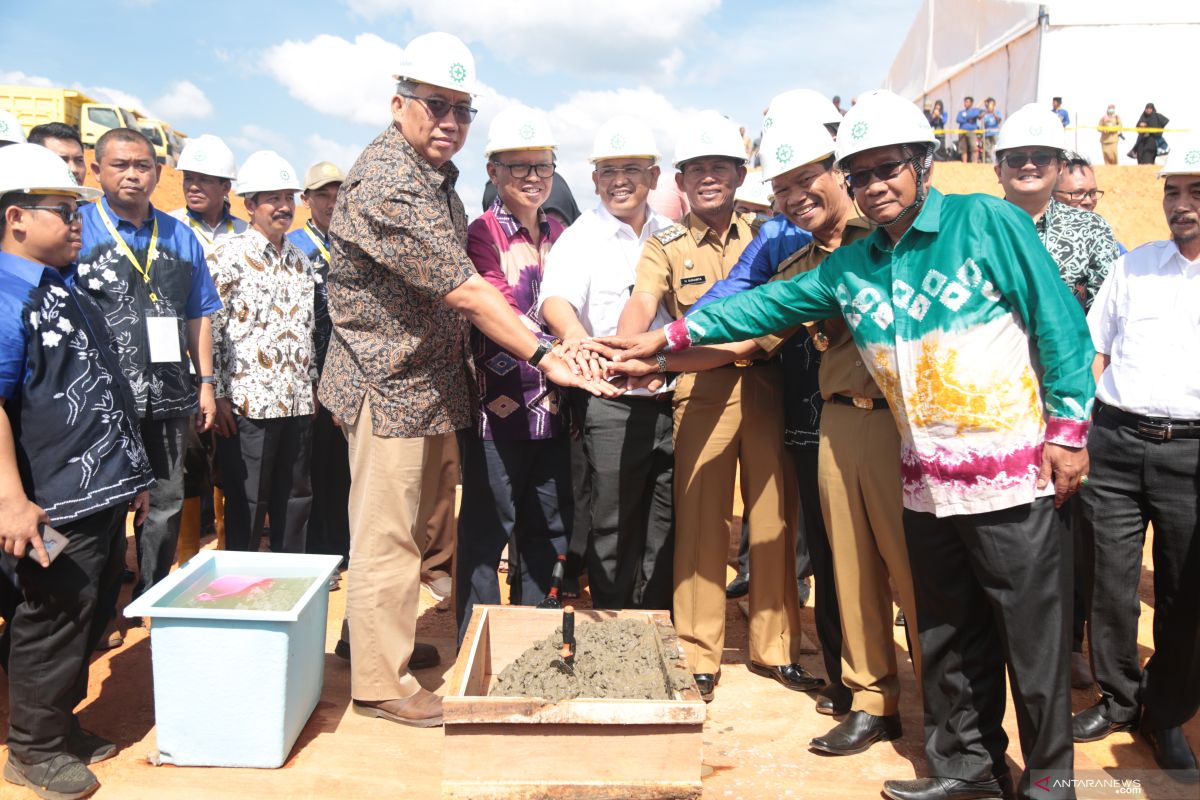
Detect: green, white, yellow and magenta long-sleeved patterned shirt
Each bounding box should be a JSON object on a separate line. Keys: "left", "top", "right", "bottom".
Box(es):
{"left": 667, "top": 191, "right": 1094, "bottom": 517}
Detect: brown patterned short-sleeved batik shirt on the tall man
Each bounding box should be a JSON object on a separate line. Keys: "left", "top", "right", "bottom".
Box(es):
{"left": 319, "top": 126, "right": 475, "bottom": 438}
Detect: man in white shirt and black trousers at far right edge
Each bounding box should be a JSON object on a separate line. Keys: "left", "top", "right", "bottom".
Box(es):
{"left": 1073, "top": 139, "right": 1200, "bottom": 783}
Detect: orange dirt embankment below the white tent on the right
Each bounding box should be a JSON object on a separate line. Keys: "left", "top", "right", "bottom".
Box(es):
{"left": 934, "top": 162, "right": 1170, "bottom": 249}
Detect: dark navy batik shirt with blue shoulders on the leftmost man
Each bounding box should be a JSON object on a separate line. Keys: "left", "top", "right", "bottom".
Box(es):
{"left": 0, "top": 253, "right": 154, "bottom": 525}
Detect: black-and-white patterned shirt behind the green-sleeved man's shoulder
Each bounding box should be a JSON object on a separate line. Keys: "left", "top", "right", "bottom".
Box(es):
{"left": 1034, "top": 198, "right": 1120, "bottom": 313}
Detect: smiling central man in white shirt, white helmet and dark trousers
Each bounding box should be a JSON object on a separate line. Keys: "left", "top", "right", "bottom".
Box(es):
{"left": 538, "top": 116, "right": 674, "bottom": 608}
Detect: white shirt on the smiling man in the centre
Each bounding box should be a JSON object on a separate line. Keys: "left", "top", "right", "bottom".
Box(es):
{"left": 536, "top": 205, "right": 672, "bottom": 336}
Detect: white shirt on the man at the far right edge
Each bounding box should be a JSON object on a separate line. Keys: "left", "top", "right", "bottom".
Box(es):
{"left": 1087, "top": 241, "right": 1200, "bottom": 420}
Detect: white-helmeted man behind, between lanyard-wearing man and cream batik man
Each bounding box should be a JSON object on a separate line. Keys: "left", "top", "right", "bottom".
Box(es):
{"left": 170, "top": 133, "right": 248, "bottom": 255}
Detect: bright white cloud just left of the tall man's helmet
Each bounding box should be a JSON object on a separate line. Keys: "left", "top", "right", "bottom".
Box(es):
{"left": 265, "top": 34, "right": 404, "bottom": 128}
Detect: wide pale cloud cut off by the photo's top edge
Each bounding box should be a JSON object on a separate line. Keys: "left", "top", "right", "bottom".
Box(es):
{"left": 346, "top": 0, "right": 720, "bottom": 77}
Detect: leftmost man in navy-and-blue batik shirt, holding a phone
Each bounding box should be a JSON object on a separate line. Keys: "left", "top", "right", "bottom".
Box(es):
{"left": 0, "top": 144, "right": 154, "bottom": 798}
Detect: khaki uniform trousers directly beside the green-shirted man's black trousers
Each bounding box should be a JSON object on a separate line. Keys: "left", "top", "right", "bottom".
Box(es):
{"left": 817, "top": 403, "right": 920, "bottom": 716}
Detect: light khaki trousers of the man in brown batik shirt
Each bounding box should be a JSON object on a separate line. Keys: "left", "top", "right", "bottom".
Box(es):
{"left": 346, "top": 399, "right": 455, "bottom": 700}
